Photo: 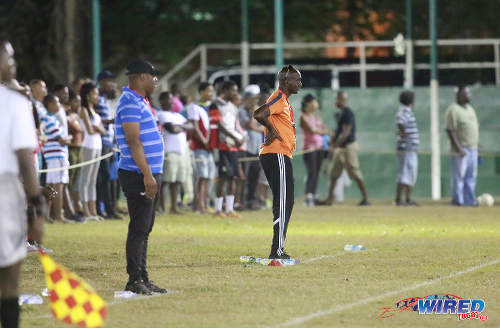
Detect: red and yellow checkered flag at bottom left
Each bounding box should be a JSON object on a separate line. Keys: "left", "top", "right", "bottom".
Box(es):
{"left": 40, "top": 253, "right": 106, "bottom": 328}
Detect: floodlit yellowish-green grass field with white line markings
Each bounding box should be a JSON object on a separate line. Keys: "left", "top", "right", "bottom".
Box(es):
{"left": 21, "top": 200, "right": 500, "bottom": 327}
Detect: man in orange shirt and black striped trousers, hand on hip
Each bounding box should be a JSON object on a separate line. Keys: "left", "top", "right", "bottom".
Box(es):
{"left": 254, "top": 65, "right": 302, "bottom": 259}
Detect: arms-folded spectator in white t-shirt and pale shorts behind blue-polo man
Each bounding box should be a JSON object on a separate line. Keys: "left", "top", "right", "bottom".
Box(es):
{"left": 158, "top": 92, "right": 189, "bottom": 214}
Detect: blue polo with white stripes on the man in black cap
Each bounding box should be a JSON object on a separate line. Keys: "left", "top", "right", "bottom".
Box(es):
{"left": 115, "top": 87, "right": 163, "bottom": 174}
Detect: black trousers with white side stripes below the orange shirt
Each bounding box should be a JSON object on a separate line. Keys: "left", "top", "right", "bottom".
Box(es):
{"left": 259, "top": 154, "right": 294, "bottom": 255}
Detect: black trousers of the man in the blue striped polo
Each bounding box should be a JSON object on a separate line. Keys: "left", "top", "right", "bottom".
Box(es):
{"left": 118, "top": 169, "right": 161, "bottom": 282}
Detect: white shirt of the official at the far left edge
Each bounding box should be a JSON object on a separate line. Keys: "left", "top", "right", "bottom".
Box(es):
{"left": 0, "top": 85, "right": 38, "bottom": 175}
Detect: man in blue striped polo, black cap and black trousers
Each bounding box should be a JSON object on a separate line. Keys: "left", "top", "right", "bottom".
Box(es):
{"left": 115, "top": 60, "right": 167, "bottom": 295}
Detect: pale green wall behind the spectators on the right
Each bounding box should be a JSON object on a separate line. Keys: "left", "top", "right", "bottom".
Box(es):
{"left": 290, "top": 86, "right": 500, "bottom": 198}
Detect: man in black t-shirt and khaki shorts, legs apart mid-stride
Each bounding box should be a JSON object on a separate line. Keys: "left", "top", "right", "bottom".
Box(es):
{"left": 323, "top": 91, "right": 370, "bottom": 206}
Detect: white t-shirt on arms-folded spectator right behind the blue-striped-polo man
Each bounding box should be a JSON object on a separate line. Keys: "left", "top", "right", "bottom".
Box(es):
{"left": 158, "top": 111, "right": 187, "bottom": 155}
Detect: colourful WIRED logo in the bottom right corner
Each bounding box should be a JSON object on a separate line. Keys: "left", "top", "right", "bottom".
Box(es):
{"left": 379, "top": 294, "right": 488, "bottom": 322}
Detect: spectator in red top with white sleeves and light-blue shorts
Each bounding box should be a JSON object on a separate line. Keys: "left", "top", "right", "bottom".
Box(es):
{"left": 187, "top": 82, "right": 215, "bottom": 214}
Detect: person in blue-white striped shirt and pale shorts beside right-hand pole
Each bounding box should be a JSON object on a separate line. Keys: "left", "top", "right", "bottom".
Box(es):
{"left": 396, "top": 91, "right": 419, "bottom": 206}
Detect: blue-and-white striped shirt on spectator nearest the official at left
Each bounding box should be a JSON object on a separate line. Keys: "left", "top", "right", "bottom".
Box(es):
{"left": 41, "top": 112, "right": 68, "bottom": 160}
